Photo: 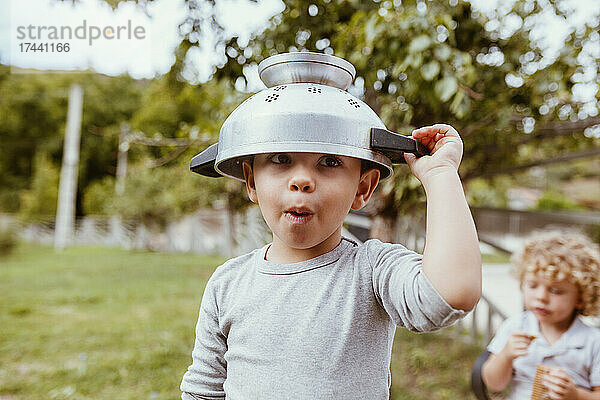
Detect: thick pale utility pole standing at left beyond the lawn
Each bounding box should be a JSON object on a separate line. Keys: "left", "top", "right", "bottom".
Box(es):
{"left": 54, "top": 84, "right": 83, "bottom": 250}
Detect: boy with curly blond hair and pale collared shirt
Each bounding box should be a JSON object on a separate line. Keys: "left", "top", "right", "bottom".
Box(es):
{"left": 482, "top": 232, "right": 600, "bottom": 400}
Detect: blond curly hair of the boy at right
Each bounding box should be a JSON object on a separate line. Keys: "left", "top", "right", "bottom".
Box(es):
{"left": 513, "top": 231, "right": 600, "bottom": 316}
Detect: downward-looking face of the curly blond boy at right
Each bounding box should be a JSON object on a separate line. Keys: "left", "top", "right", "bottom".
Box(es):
{"left": 523, "top": 271, "right": 581, "bottom": 329}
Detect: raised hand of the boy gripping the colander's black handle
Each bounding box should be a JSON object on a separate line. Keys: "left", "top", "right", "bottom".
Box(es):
{"left": 404, "top": 124, "right": 463, "bottom": 183}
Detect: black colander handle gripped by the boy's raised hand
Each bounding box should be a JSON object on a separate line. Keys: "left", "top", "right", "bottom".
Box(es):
{"left": 371, "top": 128, "right": 429, "bottom": 164}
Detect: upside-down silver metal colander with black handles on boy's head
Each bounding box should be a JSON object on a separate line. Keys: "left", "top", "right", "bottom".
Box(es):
{"left": 190, "top": 52, "right": 428, "bottom": 180}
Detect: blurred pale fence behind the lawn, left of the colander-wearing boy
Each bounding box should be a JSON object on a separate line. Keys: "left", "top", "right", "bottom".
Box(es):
{"left": 0, "top": 207, "right": 271, "bottom": 255}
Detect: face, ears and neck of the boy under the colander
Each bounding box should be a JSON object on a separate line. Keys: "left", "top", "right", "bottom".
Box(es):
{"left": 244, "top": 153, "right": 379, "bottom": 262}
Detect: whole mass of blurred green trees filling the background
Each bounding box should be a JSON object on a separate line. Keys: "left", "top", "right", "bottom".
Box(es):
{"left": 0, "top": 0, "right": 600, "bottom": 225}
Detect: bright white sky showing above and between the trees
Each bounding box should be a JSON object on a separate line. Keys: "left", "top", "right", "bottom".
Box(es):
{"left": 0, "top": 0, "right": 600, "bottom": 97}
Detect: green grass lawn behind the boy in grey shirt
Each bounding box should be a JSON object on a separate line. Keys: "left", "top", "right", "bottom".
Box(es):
{"left": 0, "top": 245, "right": 480, "bottom": 400}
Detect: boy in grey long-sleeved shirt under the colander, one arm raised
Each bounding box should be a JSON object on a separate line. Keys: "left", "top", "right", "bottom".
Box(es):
{"left": 181, "top": 124, "right": 481, "bottom": 400}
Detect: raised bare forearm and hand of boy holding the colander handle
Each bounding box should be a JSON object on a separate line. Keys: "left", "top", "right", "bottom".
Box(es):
{"left": 405, "top": 124, "right": 481, "bottom": 310}
